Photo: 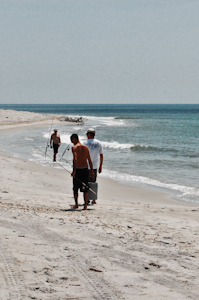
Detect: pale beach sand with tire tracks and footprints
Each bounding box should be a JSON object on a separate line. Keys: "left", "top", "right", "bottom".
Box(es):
{"left": 0, "top": 110, "right": 199, "bottom": 300}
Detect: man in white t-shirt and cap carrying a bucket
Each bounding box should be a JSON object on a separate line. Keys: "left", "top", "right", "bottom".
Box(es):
{"left": 84, "top": 128, "right": 104, "bottom": 204}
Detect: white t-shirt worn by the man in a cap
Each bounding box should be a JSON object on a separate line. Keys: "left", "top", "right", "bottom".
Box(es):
{"left": 84, "top": 139, "right": 103, "bottom": 169}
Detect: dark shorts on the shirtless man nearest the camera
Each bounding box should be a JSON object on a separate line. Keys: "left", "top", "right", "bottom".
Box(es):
{"left": 73, "top": 168, "right": 89, "bottom": 195}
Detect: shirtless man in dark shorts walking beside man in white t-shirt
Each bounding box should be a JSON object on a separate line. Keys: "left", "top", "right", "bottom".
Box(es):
{"left": 70, "top": 133, "right": 94, "bottom": 210}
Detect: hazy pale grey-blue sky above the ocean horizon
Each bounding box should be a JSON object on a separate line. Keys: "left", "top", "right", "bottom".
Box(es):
{"left": 0, "top": 0, "right": 199, "bottom": 104}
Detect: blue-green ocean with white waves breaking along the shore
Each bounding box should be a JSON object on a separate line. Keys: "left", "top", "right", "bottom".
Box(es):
{"left": 0, "top": 104, "right": 199, "bottom": 203}
